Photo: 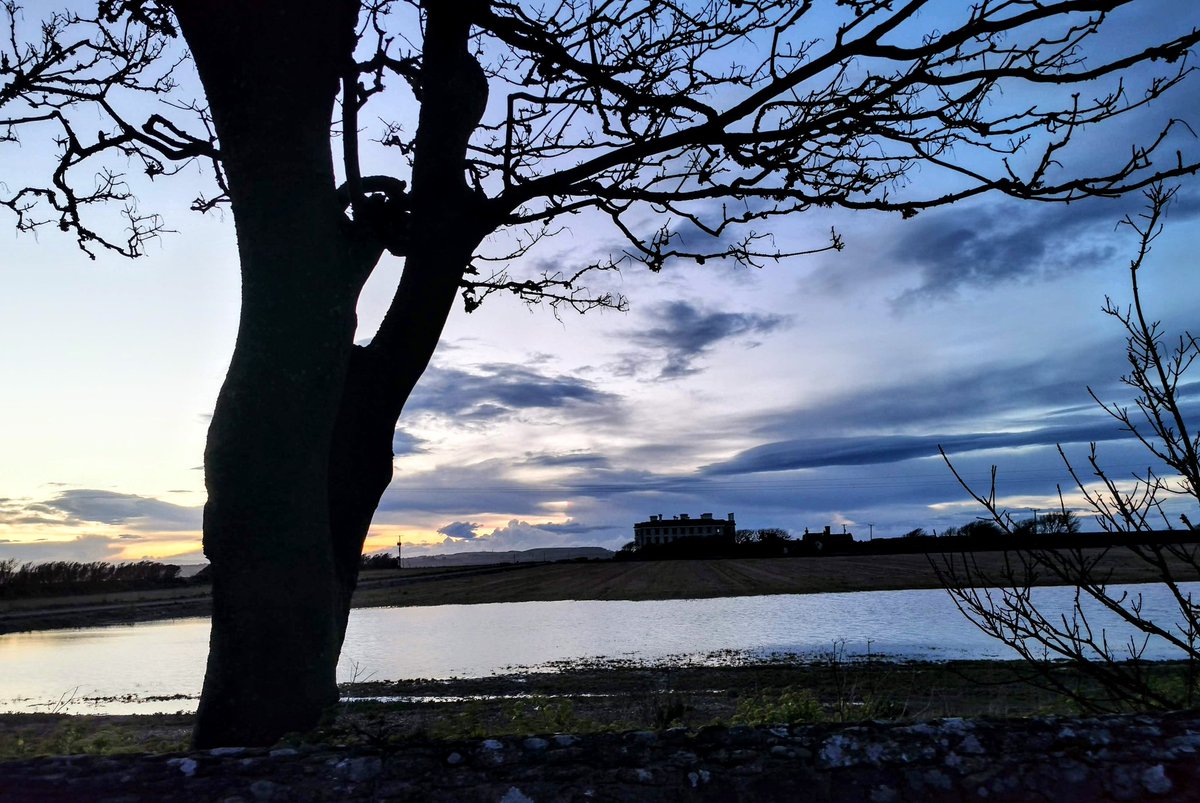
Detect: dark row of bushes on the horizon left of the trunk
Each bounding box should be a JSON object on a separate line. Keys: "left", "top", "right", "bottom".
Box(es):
{"left": 0, "top": 559, "right": 208, "bottom": 599}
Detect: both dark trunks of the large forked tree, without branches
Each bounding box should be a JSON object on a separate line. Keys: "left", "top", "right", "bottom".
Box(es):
{"left": 175, "top": 0, "right": 488, "bottom": 748}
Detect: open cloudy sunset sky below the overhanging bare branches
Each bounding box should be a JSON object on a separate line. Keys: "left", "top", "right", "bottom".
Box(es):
{"left": 0, "top": 2, "right": 1200, "bottom": 563}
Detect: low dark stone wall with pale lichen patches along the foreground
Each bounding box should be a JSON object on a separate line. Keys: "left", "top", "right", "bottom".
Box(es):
{"left": 0, "top": 713, "right": 1200, "bottom": 803}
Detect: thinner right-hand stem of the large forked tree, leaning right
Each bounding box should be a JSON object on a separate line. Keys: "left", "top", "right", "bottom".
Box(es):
{"left": 329, "top": 4, "right": 487, "bottom": 643}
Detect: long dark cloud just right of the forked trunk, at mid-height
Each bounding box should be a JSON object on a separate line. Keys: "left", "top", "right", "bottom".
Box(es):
{"left": 404, "top": 362, "right": 618, "bottom": 421}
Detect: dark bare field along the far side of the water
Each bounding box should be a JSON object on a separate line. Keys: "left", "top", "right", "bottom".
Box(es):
{"left": 0, "top": 550, "right": 1195, "bottom": 635}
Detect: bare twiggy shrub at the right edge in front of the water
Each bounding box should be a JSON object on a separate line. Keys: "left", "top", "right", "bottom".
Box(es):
{"left": 934, "top": 186, "right": 1200, "bottom": 711}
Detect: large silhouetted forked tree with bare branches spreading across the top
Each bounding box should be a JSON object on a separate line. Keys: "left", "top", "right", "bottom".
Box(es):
{"left": 0, "top": 0, "right": 1198, "bottom": 747}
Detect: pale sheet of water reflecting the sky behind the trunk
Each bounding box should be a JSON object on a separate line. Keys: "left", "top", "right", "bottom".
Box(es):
{"left": 0, "top": 583, "right": 1200, "bottom": 713}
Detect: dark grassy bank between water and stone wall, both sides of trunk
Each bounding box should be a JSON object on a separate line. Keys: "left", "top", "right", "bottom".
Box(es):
{"left": 0, "top": 647, "right": 1178, "bottom": 760}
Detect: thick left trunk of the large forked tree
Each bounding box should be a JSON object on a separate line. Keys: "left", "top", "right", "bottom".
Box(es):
{"left": 176, "top": 1, "right": 373, "bottom": 748}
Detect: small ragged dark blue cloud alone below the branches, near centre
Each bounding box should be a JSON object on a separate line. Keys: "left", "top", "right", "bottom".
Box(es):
{"left": 634, "top": 301, "right": 788, "bottom": 379}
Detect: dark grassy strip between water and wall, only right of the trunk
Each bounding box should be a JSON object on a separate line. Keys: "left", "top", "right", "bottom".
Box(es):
{"left": 334, "top": 643, "right": 1200, "bottom": 741}
